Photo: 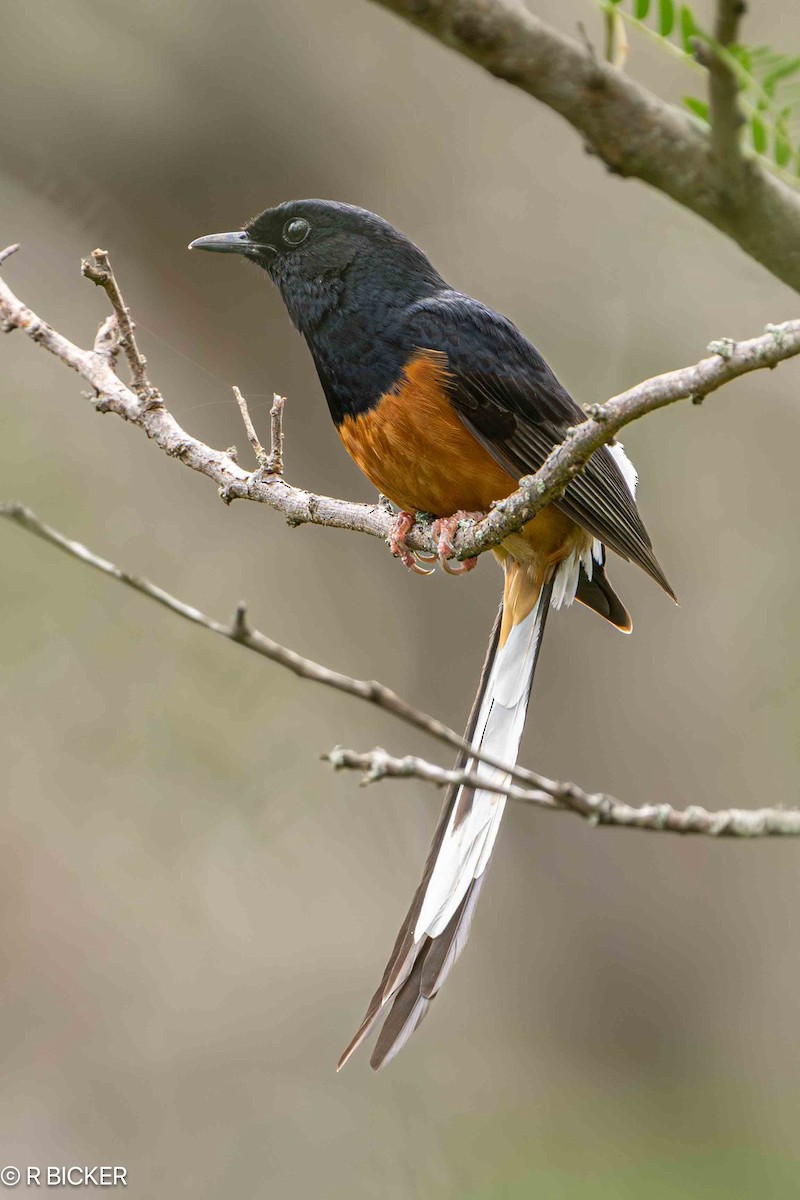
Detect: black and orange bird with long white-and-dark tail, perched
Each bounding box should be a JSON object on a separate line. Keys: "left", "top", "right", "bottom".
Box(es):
{"left": 191, "top": 200, "right": 674, "bottom": 1069}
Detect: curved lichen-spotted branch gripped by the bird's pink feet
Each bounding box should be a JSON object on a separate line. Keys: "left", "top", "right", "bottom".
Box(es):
{"left": 0, "top": 246, "right": 800, "bottom": 559}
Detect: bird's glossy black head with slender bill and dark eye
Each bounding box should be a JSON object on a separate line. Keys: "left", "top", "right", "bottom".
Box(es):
{"left": 190, "top": 200, "right": 444, "bottom": 337}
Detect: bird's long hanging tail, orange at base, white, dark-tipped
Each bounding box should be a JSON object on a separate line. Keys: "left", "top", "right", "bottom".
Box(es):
{"left": 338, "top": 560, "right": 553, "bottom": 1070}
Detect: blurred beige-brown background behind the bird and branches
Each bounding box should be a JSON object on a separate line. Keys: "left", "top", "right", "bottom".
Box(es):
{"left": 0, "top": 0, "right": 800, "bottom": 1200}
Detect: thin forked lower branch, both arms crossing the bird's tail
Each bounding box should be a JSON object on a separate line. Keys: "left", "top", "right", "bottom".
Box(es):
{"left": 6, "top": 504, "right": 800, "bottom": 838}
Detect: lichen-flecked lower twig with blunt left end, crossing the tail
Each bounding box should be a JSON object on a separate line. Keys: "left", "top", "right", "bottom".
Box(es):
{"left": 324, "top": 746, "right": 800, "bottom": 838}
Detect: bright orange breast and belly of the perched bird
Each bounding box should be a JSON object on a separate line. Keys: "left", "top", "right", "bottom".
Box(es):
{"left": 339, "top": 350, "right": 578, "bottom": 560}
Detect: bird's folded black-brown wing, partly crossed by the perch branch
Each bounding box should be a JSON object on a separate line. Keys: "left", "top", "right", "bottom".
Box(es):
{"left": 405, "top": 292, "right": 674, "bottom": 598}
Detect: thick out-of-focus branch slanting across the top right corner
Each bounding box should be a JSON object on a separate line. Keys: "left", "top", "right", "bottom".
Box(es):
{"left": 373, "top": 0, "right": 800, "bottom": 290}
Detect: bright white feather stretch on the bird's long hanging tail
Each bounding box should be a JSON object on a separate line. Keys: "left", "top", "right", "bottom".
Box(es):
{"left": 414, "top": 587, "right": 551, "bottom": 942}
